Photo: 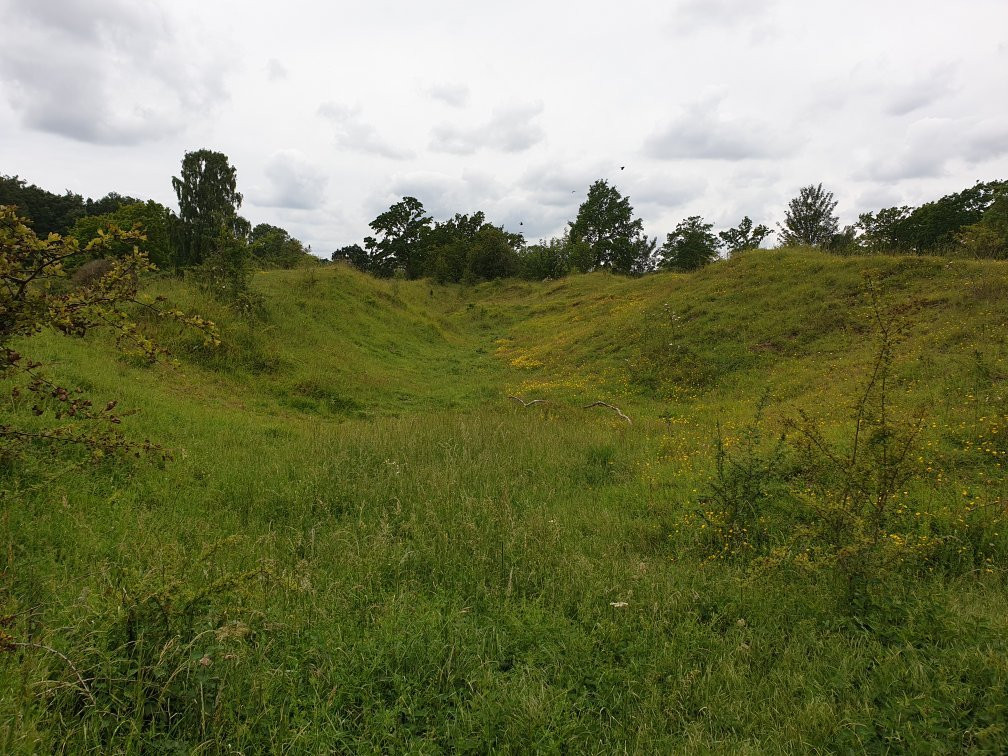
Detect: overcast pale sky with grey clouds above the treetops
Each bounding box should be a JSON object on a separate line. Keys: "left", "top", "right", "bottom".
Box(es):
{"left": 0, "top": 0, "right": 1008, "bottom": 257}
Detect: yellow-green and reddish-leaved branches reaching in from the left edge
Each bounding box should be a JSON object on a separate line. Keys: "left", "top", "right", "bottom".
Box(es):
{"left": 0, "top": 206, "right": 219, "bottom": 457}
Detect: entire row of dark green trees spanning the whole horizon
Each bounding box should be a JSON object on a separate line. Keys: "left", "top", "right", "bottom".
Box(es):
{"left": 0, "top": 149, "right": 1008, "bottom": 298}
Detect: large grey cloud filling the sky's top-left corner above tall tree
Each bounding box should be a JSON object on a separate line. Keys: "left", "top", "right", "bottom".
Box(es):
{"left": 0, "top": 0, "right": 227, "bottom": 145}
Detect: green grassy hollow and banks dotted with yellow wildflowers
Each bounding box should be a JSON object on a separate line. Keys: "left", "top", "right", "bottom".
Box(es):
{"left": 0, "top": 250, "right": 1008, "bottom": 753}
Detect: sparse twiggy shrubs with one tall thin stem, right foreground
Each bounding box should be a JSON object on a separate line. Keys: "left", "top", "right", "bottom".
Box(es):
{"left": 691, "top": 279, "right": 957, "bottom": 608}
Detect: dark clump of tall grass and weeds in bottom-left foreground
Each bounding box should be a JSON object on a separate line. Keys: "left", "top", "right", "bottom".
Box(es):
{"left": 18, "top": 537, "right": 270, "bottom": 750}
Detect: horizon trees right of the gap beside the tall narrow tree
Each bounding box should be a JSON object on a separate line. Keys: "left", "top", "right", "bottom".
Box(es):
{"left": 332, "top": 179, "right": 1008, "bottom": 282}
